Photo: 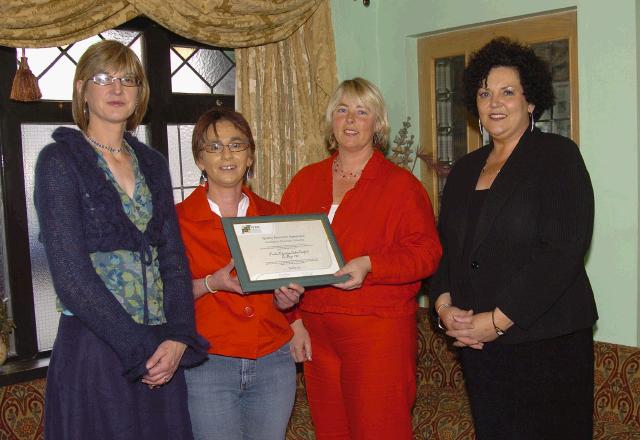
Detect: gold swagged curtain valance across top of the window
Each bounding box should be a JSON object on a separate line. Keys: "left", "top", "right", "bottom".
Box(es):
{"left": 0, "top": 0, "right": 322, "bottom": 48}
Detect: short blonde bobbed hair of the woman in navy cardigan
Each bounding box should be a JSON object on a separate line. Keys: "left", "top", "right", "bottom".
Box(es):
{"left": 71, "top": 40, "right": 149, "bottom": 131}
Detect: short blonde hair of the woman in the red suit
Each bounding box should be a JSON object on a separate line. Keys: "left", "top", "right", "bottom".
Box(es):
{"left": 324, "top": 78, "right": 389, "bottom": 151}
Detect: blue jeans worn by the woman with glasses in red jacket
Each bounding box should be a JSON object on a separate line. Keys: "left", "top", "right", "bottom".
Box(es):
{"left": 185, "top": 343, "right": 296, "bottom": 440}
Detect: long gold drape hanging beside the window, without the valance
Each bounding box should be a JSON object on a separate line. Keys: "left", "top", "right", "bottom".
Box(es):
{"left": 236, "top": 1, "right": 337, "bottom": 200}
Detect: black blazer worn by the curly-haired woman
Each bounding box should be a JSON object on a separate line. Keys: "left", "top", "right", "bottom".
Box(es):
{"left": 429, "top": 129, "right": 598, "bottom": 344}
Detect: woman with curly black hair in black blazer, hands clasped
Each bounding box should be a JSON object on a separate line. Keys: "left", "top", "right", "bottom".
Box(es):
{"left": 430, "top": 38, "right": 597, "bottom": 440}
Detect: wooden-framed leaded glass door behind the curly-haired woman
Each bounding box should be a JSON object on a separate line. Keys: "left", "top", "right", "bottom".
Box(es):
{"left": 418, "top": 10, "right": 578, "bottom": 212}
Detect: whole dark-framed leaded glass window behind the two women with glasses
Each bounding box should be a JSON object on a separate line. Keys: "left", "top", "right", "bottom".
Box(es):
{"left": 0, "top": 18, "right": 235, "bottom": 359}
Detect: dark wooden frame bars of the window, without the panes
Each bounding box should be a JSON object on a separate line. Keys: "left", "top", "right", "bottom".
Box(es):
{"left": 0, "top": 17, "right": 235, "bottom": 374}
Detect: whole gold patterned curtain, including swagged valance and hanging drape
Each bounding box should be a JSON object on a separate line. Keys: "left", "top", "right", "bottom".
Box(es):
{"left": 0, "top": 0, "right": 337, "bottom": 200}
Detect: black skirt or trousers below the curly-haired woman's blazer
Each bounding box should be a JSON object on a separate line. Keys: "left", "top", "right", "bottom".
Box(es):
{"left": 461, "top": 328, "right": 594, "bottom": 440}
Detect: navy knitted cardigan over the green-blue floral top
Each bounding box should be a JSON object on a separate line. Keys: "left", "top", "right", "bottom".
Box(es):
{"left": 34, "top": 127, "right": 207, "bottom": 380}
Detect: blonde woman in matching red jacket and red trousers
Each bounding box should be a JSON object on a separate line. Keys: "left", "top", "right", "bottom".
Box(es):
{"left": 282, "top": 78, "right": 441, "bottom": 439}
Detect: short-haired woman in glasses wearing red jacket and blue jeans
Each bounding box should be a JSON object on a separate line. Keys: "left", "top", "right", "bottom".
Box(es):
{"left": 177, "top": 109, "right": 302, "bottom": 440}
